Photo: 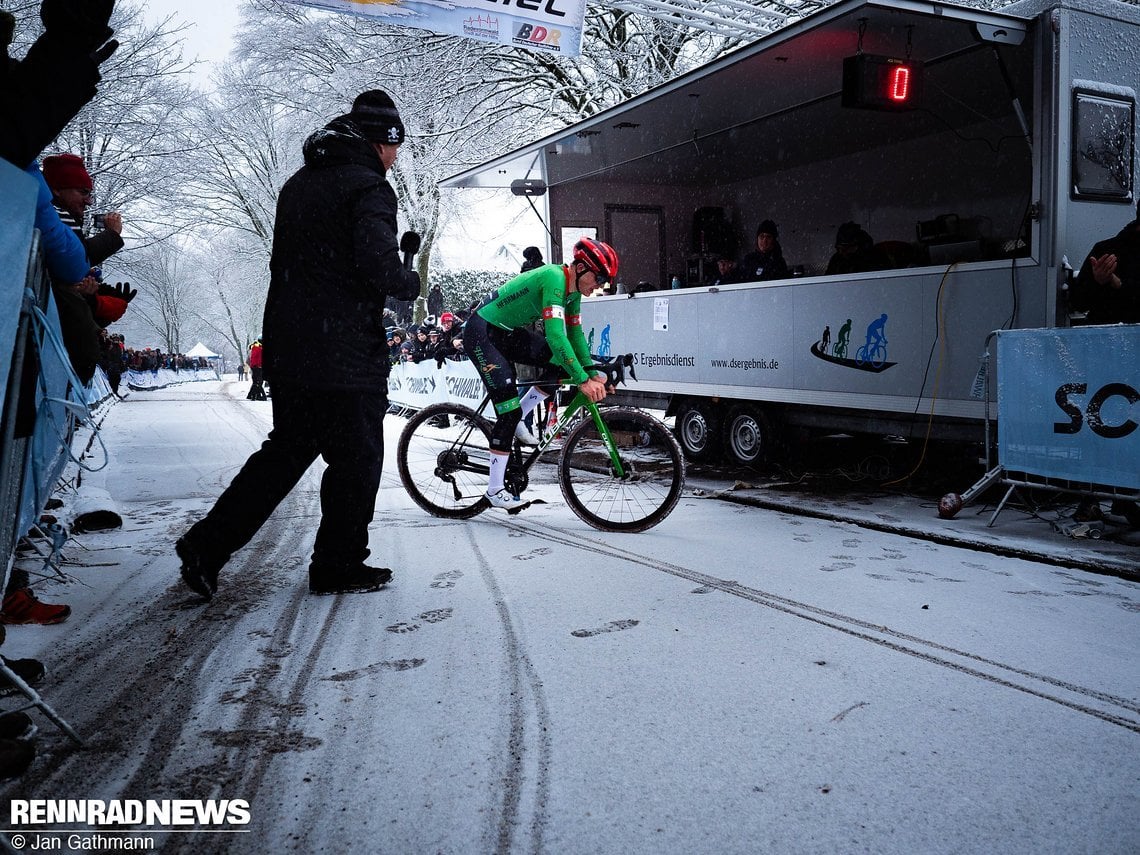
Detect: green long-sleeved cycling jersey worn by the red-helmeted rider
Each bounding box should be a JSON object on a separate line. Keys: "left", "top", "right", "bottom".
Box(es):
{"left": 479, "top": 264, "right": 593, "bottom": 385}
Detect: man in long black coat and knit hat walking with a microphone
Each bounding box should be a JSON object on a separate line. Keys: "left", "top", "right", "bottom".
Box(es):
{"left": 176, "top": 90, "right": 420, "bottom": 599}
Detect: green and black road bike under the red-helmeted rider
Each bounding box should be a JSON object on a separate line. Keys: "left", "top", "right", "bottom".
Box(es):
{"left": 396, "top": 353, "right": 685, "bottom": 531}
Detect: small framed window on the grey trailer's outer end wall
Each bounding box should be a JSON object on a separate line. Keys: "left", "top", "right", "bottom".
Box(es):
{"left": 1073, "top": 90, "right": 1135, "bottom": 202}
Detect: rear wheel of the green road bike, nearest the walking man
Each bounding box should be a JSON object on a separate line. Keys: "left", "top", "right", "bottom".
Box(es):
{"left": 396, "top": 404, "right": 491, "bottom": 520}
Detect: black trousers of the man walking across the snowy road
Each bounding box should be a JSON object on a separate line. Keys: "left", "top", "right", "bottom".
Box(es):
{"left": 188, "top": 383, "right": 388, "bottom": 573}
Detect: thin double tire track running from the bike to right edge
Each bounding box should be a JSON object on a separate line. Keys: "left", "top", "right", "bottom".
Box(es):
{"left": 498, "top": 520, "right": 1140, "bottom": 733}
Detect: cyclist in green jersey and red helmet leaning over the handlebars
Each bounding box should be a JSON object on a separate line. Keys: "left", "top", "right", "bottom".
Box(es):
{"left": 463, "top": 237, "right": 618, "bottom": 510}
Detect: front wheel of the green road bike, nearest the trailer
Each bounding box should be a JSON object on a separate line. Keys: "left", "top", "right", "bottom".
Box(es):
{"left": 559, "top": 407, "right": 685, "bottom": 531}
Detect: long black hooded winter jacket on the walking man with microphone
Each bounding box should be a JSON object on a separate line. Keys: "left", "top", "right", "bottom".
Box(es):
{"left": 262, "top": 116, "right": 420, "bottom": 393}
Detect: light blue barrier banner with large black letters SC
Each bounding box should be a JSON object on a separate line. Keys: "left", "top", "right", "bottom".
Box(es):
{"left": 998, "top": 324, "right": 1140, "bottom": 490}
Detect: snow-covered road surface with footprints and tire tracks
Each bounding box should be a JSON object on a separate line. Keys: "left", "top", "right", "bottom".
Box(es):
{"left": 3, "top": 382, "right": 1140, "bottom": 854}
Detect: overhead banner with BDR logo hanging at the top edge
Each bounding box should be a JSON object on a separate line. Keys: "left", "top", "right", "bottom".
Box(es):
{"left": 290, "top": 0, "right": 586, "bottom": 56}
